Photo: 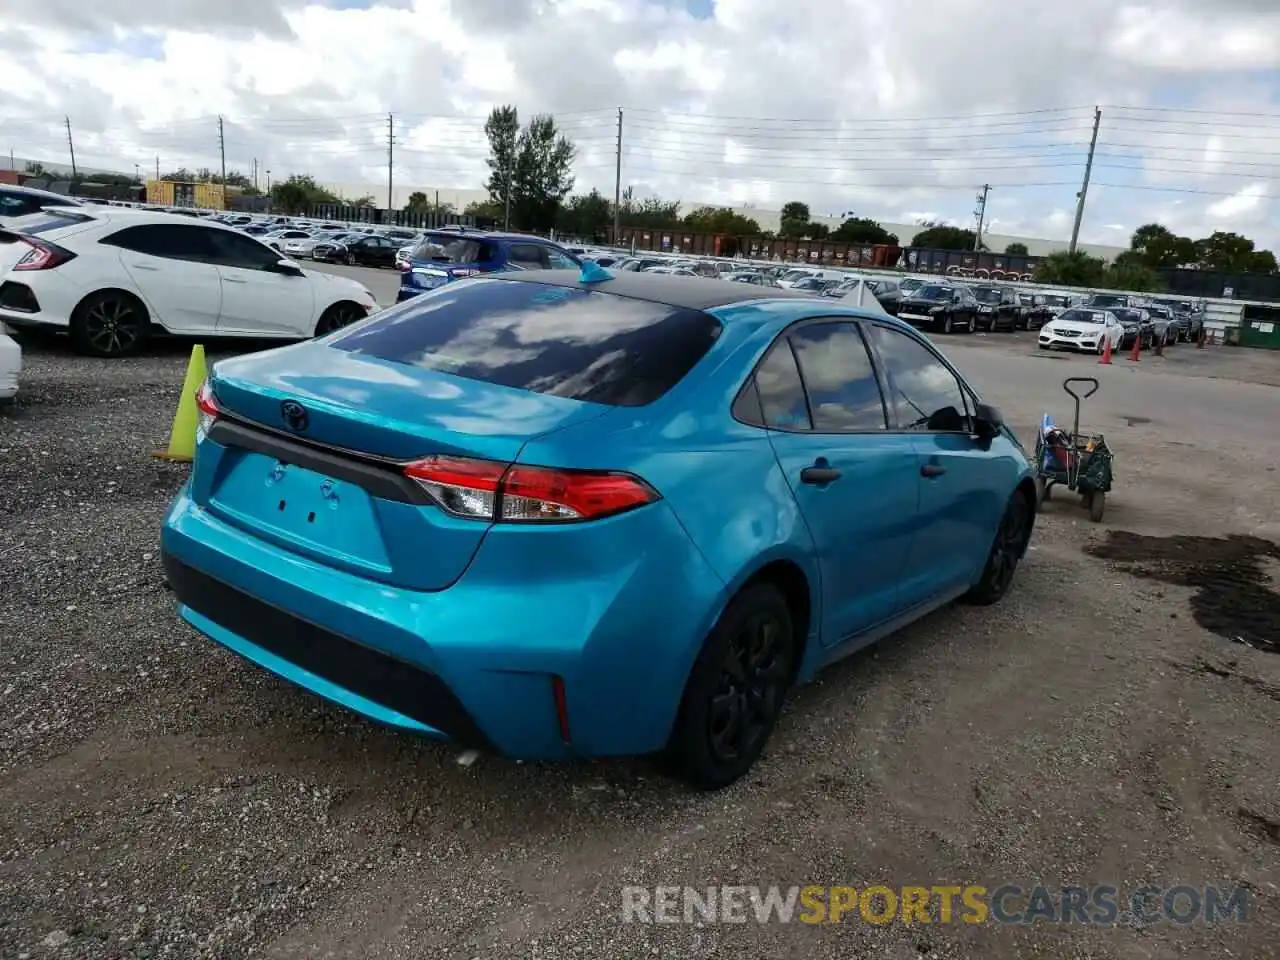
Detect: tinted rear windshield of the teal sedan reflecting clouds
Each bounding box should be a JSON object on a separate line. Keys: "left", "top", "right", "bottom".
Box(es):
{"left": 332, "top": 279, "right": 721, "bottom": 407}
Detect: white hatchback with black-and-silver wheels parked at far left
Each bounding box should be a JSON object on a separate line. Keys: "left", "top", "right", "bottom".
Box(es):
{"left": 0, "top": 206, "right": 378, "bottom": 357}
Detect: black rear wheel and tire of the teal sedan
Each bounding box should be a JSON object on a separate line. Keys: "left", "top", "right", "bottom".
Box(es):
{"left": 664, "top": 582, "right": 799, "bottom": 790}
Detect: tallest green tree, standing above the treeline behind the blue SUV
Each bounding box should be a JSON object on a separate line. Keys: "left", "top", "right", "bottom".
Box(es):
{"left": 484, "top": 105, "right": 576, "bottom": 232}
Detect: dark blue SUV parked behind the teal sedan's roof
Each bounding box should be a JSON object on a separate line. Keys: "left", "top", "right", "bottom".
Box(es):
{"left": 396, "top": 228, "right": 582, "bottom": 303}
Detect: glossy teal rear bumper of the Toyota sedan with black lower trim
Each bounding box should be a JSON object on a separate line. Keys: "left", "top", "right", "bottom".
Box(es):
{"left": 161, "top": 488, "right": 723, "bottom": 760}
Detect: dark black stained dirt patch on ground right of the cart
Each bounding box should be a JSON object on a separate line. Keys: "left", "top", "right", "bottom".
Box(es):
{"left": 1084, "top": 530, "right": 1280, "bottom": 653}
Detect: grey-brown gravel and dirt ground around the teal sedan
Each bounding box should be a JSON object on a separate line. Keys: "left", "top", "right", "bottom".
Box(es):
{"left": 0, "top": 338, "right": 1280, "bottom": 960}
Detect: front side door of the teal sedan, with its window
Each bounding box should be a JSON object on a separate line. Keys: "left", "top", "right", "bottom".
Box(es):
{"left": 867, "top": 324, "right": 1010, "bottom": 605}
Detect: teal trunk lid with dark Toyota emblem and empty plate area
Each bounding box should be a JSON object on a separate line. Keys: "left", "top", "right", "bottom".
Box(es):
{"left": 192, "top": 342, "right": 608, "bottom": 590}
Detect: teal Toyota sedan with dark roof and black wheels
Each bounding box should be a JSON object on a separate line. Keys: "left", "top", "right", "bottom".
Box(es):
{"left": 161, "top": 265, "right": 1036, "bottom": 788}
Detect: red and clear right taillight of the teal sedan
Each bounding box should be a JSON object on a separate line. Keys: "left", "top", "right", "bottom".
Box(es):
{"left": 404, "top": 457, "right": 658, "bottom": 524}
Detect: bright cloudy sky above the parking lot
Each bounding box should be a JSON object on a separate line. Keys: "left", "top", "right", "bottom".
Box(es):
{"left": 0, "top": 0, "right": 1280, "bottom": 248}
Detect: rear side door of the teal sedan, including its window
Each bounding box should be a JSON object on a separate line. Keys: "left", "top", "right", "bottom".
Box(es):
{"left": 755, "top": 320, "right": 920, "bottom": 645}
